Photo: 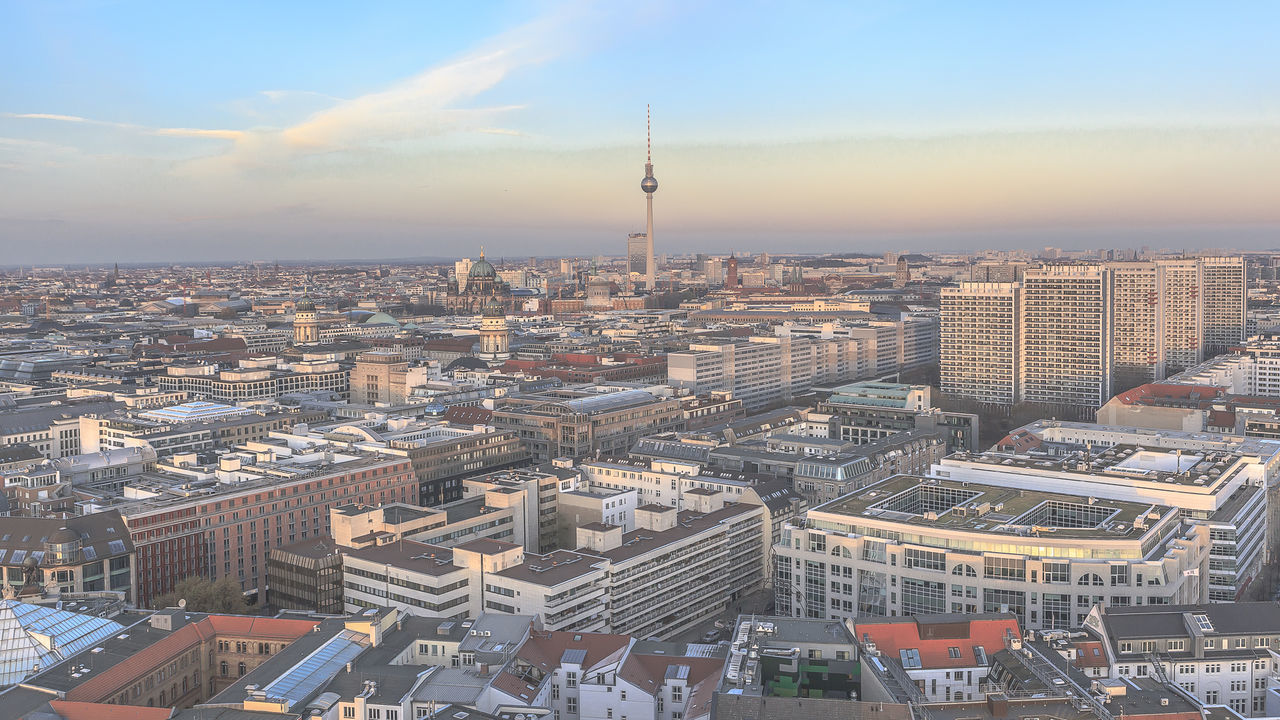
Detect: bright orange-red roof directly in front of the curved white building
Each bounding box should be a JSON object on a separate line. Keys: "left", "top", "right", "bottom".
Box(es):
{"left": 855, "top": 618, "right": 1019, "bottom": 670}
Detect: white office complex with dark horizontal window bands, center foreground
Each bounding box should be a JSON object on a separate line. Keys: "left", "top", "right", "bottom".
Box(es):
{"left": 343, "top": 489, "right": 769, "bottom": 637}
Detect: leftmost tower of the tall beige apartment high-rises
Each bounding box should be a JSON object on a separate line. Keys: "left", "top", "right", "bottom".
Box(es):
{"left": 940, "top": 282, "right": 1021, "bottom": 405}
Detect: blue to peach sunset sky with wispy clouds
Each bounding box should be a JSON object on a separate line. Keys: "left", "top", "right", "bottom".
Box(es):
{"left": 0, "top": 0, "right": 1280, "bottom": 265}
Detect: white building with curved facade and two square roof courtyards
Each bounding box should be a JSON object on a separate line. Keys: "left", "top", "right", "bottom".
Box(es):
{"left": 774, "top": 475, "right": 1211, "bottom": 629}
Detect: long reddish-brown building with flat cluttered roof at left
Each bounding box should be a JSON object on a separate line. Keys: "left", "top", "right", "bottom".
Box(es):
{"left": 81, "top": 442, "right": 417, "bottom": 606}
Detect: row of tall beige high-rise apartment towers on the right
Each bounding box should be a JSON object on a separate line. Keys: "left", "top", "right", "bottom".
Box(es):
{"left": 940, "top": 258, "right": 1245, "bottom": 407}
